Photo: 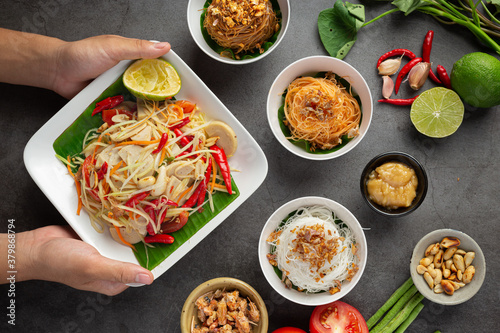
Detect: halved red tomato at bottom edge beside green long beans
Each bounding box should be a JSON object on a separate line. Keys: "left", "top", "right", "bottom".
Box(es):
{"left": 309, "top": 301, "right": 368, "bottom": 333}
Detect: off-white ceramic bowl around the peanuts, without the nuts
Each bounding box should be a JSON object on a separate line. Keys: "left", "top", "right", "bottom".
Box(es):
{"left": 410, "top": 229, "right": 486, "bottom": 305}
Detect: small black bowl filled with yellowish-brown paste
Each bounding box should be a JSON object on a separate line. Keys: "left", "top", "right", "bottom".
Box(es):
{"left": 360, "top": 152, "right": 428, "bottom": 217}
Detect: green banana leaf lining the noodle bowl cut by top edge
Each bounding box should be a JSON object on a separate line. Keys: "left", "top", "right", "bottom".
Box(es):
{"left": 200, "top": 0, "right": 282, "bottom": 60}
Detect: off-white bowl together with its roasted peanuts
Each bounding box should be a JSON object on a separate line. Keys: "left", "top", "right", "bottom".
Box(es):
{"left": 410, "top": 229, "right": 486, "bottom": 305}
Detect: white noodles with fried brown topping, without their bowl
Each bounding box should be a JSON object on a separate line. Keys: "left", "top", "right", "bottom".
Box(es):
{"left": 267, "top": 206, "right": 360, "bottom": 294}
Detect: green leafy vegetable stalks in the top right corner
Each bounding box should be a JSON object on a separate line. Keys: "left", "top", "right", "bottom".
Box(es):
{"left": 318, "top": 0, "right": 500, "bottom": 59}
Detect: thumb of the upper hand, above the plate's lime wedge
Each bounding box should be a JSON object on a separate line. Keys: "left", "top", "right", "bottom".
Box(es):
{"left": 102, "top": 36, "right": 170, "bottom": 62}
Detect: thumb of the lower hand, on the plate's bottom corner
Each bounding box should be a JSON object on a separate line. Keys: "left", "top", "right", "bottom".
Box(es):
{"left": 96, "top": 257, "right": 154, "bottom": 285}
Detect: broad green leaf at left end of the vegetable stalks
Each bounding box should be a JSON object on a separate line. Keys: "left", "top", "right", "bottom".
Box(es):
{"left": 318, "top": 0, "right": 365, "bottom": 59}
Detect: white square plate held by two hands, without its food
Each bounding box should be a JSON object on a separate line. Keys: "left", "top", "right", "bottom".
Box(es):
{"left": 24, "top": 51, "right": 267, "bottom": 279}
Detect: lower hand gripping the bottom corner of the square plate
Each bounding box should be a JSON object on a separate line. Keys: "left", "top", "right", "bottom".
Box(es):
{"left": 18, "top": 225, "right": 154, "bottom": 296}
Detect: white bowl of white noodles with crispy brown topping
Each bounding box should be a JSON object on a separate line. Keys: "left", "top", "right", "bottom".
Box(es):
{"left": 258, "top": 197, "right": 367, "bottom": 306}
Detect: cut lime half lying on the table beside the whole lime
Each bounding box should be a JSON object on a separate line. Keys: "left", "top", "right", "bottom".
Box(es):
{"left": 410, "top": 87, "right": 464, "bottom": 138}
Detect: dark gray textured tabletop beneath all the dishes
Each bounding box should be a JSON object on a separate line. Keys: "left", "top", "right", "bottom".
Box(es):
{"left": 0, "top": 0, "right": 500, "bottom": 332}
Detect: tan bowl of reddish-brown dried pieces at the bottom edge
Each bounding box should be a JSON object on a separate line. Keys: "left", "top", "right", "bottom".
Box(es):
{"left": 181, "top": 277, "right": 269, "bottom": 333}
